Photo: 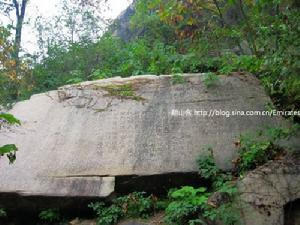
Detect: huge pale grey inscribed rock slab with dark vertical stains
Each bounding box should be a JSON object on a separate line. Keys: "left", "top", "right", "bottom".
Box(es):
{"left": 0, "top": 74, "right": 285, "bottom": 197}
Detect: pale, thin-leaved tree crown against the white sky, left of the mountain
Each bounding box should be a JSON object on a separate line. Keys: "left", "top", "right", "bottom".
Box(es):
{"left": 35, "top": 0, "right": 109, "bottom": 55}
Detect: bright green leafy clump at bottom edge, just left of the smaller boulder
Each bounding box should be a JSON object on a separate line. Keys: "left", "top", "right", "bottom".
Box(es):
{"left": 165, "top": 185, "right": 240, "bottom": 225}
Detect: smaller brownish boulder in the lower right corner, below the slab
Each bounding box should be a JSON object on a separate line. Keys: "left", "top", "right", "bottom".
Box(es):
{"left": 239, "top": 157, "right": 300, "bottom": 225}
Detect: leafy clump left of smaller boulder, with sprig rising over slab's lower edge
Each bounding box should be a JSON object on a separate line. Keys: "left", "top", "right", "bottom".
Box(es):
{"left": 165, "top": 147, "right": 240, "bottom": 225}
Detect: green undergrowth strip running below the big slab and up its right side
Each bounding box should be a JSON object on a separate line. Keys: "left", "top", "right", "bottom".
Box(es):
{"left": 89, "top": 125, "right": 299, "bottom": 225}
